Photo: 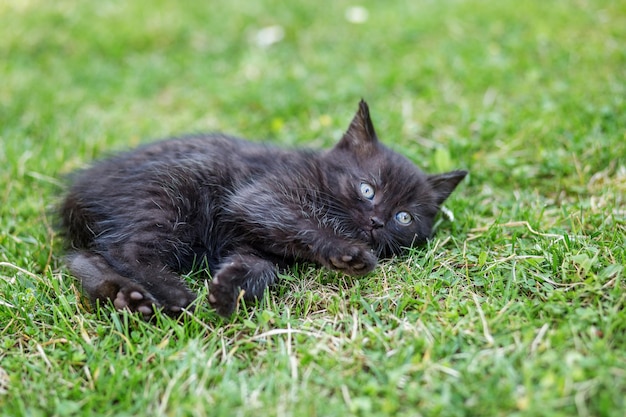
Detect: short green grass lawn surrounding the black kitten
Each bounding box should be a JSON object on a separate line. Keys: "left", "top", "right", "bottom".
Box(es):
{"left": 0, "top": 0, "right": 626, "bottom": 416}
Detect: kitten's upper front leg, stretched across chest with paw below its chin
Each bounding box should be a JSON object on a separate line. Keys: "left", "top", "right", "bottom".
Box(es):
{"left": 229, "top": 182, "right": 378, "bottom": 276}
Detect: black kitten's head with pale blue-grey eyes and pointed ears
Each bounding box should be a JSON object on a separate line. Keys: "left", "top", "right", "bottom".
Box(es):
{"left": 327, "top": 100, "right": 467, "bottom": 256}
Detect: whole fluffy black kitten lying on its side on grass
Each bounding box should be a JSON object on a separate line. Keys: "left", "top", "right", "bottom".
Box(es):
{"left": 60, "top": 100, "right": 467, "bottom": 318}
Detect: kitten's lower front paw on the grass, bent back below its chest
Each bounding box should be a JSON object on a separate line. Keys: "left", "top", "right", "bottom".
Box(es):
{"left": 209, "top": 253, "right": 277, "bottom": 316}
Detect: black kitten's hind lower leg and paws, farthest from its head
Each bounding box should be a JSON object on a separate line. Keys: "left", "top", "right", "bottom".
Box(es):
{"left": 68, "top": 251, "right": 195, "bottom": 317}
